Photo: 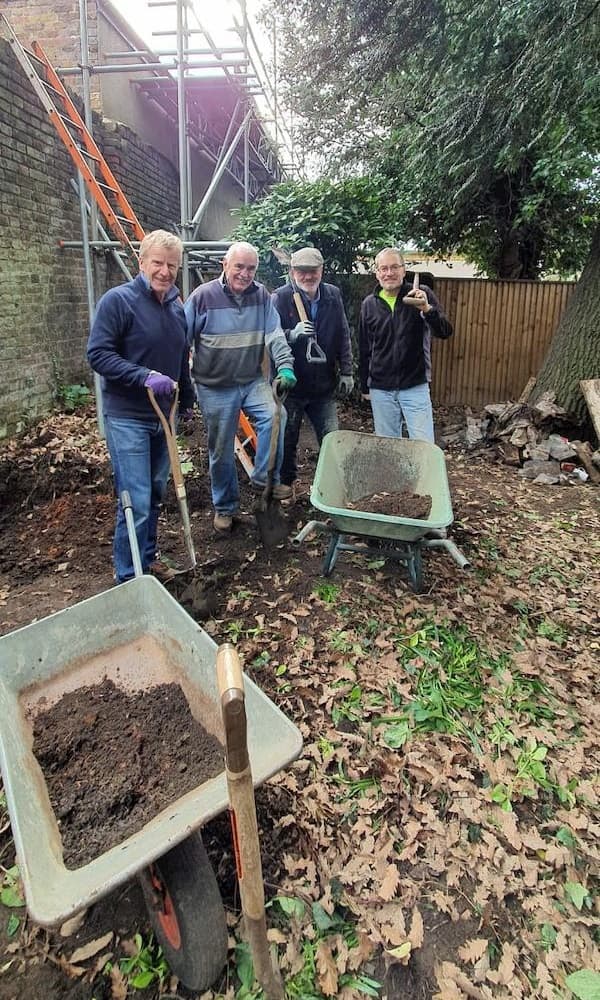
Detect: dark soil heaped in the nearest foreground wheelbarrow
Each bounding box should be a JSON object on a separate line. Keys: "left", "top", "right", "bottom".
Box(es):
{"left": 33, "top": 678, "right": 224, "bottom": 868}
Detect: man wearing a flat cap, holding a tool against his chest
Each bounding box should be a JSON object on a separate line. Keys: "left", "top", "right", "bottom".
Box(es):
{"left": 273, "top": 247, "right": 354, "bottom": 486}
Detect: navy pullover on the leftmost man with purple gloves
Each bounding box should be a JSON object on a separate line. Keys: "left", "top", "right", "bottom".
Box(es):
{"left": 87, "top": 274, "right": 195, "bottom": 419}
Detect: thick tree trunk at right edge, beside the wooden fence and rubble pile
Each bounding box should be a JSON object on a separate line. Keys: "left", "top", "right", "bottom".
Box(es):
{"left": 532, "top": 226, "right": 600, "bottom": 424}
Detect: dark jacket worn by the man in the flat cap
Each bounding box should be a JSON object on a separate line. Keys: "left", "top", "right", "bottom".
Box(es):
{"left": 273, "top": 282, "right": 352, "bottom": 399}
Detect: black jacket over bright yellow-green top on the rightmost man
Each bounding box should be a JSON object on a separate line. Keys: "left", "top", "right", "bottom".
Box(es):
{"left": 358, "top": 281, "right": 452, "bottom": 394}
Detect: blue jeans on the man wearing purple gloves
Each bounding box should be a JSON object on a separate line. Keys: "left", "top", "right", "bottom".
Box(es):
{"left": 104, "top": 416, "right": 169, "bottom": 583}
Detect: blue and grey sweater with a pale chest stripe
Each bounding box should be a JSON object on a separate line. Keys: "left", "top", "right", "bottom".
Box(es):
{"left": 185, "top": 275, "right": 294, "bottom": 387}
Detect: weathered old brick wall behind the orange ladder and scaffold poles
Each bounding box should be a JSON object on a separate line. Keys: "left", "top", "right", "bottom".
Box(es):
{"left": 0, "top": 38, "right": 185, "bottom": 438}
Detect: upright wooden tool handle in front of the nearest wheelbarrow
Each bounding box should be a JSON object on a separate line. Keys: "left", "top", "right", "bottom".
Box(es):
{"left": 217, "top": 642, "right": 284, "bottom": 1000}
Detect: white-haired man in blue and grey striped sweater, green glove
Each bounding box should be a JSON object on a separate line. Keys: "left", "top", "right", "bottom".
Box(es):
{"left": 185, "top": 242, "right": 296, "bottom": 531}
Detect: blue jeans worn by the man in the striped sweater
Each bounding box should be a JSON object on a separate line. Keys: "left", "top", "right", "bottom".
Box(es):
{"left": 196, "top": 378, "right": 285, "bottom": 515}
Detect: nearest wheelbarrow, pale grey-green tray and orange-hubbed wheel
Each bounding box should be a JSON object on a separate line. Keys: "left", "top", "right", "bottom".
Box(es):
{"left": 0, "top": 564, "right": 302, "bottom": 991}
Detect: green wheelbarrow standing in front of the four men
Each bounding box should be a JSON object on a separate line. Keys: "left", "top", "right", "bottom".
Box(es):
{"left": 293, "top": 431, "right": 469, "bottom": 593}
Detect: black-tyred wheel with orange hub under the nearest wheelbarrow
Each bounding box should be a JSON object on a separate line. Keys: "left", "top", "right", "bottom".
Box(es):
{"left": 140, "top": 833, "right": 227, "bottom": 990}
